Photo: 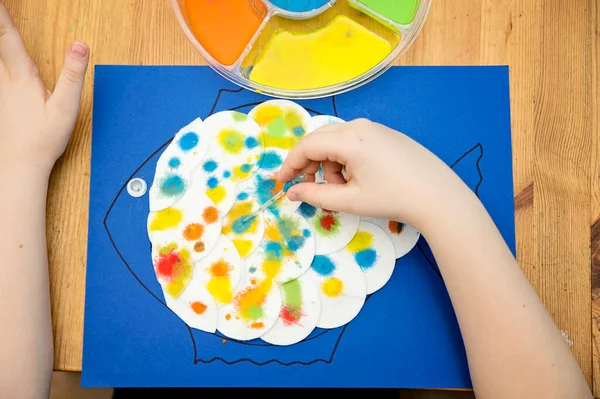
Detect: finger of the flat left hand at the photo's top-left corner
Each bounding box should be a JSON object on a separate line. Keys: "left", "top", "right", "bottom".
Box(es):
{"left": 0, "top": 2, "right": 34, "bottom": 76}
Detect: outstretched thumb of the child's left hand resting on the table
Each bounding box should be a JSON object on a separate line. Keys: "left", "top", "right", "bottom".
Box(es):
{"left": 46, "top": 41, "right": 90, "bottom": 119}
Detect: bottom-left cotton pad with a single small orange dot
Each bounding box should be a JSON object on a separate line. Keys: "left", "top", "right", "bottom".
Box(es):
{"left": 163, "top": 281, "right": 218, "bottom": 333}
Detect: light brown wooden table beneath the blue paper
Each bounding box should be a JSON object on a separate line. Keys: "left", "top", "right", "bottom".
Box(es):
{"left": 4, "top": 0, "right": 600, "bottom": 394}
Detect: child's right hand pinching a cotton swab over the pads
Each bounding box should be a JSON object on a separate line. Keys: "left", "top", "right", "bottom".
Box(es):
{"left": 279, "top": 119, "right": 470, "bottom": 230}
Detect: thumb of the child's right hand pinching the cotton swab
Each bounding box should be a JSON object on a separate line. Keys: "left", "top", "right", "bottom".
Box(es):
{"left": 287, "top": 183, "right": 351, "bottom": 212}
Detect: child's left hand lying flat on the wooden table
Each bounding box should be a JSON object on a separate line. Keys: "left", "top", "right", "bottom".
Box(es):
{"left": 0, "top": 2, "right": 90, "bottom": 177}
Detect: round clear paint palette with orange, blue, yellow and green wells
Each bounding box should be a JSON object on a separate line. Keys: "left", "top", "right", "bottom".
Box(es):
{"left": 172, "top": 0, "right": 431, "bottom": 99}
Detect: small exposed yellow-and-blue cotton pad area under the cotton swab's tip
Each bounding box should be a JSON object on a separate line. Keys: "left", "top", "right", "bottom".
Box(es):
{"left": 222, "top": 198, "right": 265, "bottom": 259}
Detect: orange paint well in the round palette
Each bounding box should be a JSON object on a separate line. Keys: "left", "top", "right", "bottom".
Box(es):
{"left": 185, "top": 0, "right": 266, "bottom": 65}
